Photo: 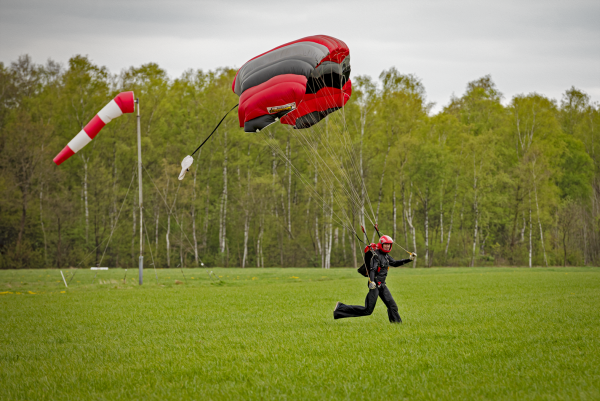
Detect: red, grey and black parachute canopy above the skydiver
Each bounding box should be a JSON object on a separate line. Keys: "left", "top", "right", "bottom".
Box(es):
{"left": 232, "top": 35, "right": 352, "bottom": 132}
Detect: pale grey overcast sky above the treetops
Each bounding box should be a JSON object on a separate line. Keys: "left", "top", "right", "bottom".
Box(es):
{"left": 0, "top": 0, "right": 600, "bottom": 110}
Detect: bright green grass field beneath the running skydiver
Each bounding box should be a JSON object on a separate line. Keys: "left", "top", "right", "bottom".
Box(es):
{"left": 0, "top": 268, "right": 600, "bottom": 400}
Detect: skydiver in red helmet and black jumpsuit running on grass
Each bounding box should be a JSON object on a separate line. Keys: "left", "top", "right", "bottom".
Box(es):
{"left": 333, "top": 235, "right": 417, "bottom": 323}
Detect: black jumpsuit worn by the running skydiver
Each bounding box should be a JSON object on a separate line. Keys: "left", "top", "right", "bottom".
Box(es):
{"left": 333, "top": 249, "right": 411, "bottom": 323}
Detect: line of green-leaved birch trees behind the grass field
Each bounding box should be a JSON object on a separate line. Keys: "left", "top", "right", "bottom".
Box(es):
{"left": 0, "top": 56, "right": 600, "bottom": 268}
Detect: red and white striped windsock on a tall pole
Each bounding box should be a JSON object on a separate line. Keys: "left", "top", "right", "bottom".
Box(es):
{"left": 54, "top": 92, "right": 135, "bottom": 166}
